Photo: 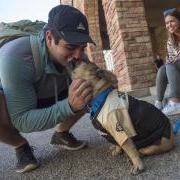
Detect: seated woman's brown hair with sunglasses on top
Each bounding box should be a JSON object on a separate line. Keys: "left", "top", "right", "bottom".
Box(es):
{"left": 163, "top": 8, "right": 180, "bottom": 47}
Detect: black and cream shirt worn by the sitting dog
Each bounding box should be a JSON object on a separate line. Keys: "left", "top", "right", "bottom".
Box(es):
{"left": 91, "top": 89, "right": 170, "bottom": 149}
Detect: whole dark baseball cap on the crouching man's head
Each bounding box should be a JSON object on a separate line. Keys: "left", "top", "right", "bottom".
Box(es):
{"left": 47, "top": 5, "right": 95, "bottom": 45}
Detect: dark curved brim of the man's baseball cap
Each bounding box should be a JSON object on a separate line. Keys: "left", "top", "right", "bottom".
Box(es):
{"left": 63, "top": 32, "right": 96, "bottom": 45}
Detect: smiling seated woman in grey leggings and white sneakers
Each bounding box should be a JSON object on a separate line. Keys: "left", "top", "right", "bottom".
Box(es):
{"left": 155, "top": 8, "right": 180, "bottom": 115}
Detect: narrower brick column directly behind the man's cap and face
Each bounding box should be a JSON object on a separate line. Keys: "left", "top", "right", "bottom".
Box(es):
{"left": 73, "top": 0, "right": 105, "bottom": 68}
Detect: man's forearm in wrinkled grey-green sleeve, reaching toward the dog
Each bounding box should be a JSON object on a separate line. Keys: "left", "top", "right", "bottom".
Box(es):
{"left": 12, "top": 99, "right": 74, "bottom": 133}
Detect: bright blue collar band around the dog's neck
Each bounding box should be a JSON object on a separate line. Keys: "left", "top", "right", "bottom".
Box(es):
{"left": 90, "top": 86, "right": 114, "bottom": 120}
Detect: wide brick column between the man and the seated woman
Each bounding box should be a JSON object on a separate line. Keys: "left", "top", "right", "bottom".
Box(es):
{"left": 102, "top": 0, "right": 155, "bottom": 90}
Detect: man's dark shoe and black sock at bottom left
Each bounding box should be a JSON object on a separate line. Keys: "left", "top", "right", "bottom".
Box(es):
{"left": 16, "top": 144, "right": 39, "bottom": 173}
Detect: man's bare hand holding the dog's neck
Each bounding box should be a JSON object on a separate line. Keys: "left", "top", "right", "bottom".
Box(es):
{"left": 68, "top": 79, "right": 93, "bottom": 112}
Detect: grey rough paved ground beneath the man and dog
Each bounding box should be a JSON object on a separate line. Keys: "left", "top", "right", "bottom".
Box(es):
{"left": 0, "top": 110, "right": 180, "bottom": 180}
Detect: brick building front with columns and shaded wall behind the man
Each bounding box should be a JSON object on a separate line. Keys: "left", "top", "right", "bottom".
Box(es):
{"left": 60, "top": 0, "right": 180, "bottom": 91}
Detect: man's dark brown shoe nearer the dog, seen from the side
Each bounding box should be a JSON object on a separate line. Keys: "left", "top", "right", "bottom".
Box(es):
{"left": 50, "top": 132, "right": 86, "bottom": 151}
